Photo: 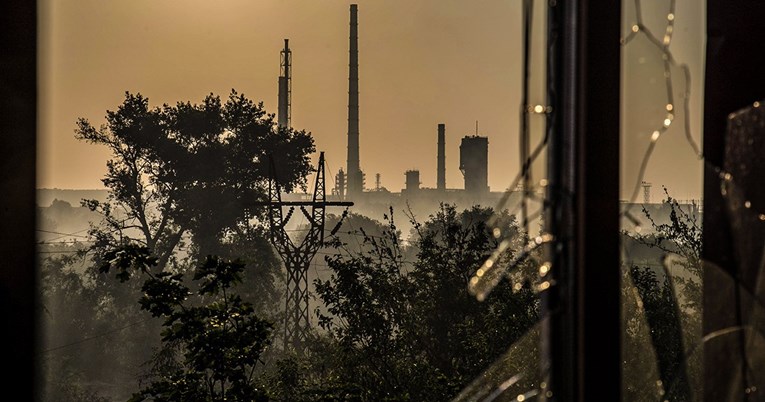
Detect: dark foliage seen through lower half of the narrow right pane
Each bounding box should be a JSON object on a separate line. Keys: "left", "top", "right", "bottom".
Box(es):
{"left": 622, "top": 189, "right": 702, "bottom": 401}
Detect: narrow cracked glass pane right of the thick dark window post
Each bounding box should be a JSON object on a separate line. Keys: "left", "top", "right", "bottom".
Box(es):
{"left": 620, "top": 0, "right": 704, "bottom": 401}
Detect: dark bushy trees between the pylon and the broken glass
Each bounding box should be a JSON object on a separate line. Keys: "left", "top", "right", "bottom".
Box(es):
{"left": 298, "top": 206, "right": 538, "bottom": 401}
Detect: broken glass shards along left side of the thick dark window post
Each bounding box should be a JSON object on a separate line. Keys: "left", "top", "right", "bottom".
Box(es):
{"left": 453, "top": 0, "right": 557, "bottom": 402}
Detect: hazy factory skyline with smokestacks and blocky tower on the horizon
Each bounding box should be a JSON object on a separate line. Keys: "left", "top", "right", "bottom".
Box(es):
{"left": 277, "top": 4, "right": 522, "bottom": 226}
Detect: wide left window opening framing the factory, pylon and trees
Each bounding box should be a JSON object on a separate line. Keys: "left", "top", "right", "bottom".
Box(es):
{"left": 37, "top": 0, "right": 552, "bottom": 401}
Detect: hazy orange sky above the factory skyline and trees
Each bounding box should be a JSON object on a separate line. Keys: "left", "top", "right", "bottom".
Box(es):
{"left": 38, "top": 0, "right": 702, "bottom": 201}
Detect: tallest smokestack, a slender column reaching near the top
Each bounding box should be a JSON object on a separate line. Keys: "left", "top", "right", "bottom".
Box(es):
{"left": 346, "top": 4, "right": 363, "bottom": 194}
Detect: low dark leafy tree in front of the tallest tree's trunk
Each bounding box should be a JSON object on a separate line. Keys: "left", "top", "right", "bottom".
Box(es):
{"left": 99, "top": 245, "right": 272, "bottom": 402}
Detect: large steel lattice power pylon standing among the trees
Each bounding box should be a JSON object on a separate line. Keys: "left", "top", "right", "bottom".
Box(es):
{"left": 268, "top": 152, "right": 353, "bottom": 352}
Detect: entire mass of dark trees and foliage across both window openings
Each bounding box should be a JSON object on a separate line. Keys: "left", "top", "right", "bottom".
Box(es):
{"left": 39, "top": 91, "right": 699, "bottom": 401}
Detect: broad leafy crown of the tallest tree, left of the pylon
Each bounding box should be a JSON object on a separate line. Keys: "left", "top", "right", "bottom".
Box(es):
{"left": 76, "top": 91, "right": 314, "bottom": 266}
